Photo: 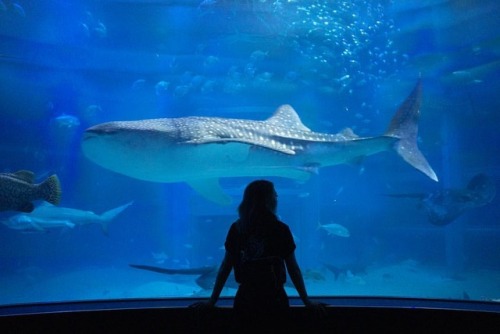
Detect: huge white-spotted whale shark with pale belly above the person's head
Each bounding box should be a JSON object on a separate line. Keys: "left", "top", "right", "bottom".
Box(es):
{"left": 81, "top": 80, "right": 438, "bottom": 205}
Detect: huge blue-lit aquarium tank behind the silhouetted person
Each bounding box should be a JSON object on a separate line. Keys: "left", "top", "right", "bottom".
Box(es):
{"left": 0, "top": 0, "right": 500, "bottom": 314}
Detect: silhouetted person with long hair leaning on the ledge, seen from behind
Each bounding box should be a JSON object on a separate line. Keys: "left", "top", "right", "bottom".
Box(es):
{"left": 190, "top": 180, "right": 326, "bottom": 329}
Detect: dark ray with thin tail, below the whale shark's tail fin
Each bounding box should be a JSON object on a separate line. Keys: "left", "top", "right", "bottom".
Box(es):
{"left": 385, "top": 173, "right": 496, "bottom": 226}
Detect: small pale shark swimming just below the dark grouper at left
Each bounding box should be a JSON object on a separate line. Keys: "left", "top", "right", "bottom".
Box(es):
{"left": 3, "top": 201, "right": 133, "bottom": 235}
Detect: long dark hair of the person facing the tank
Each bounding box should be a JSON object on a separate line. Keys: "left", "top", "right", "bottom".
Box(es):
{"left": 238, "top": 180, "right": 278, "bottom": 234}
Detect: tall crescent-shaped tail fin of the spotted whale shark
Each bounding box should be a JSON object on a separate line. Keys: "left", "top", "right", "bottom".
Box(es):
{"left": 385, "top": 79, "right": 438, "bottom": 182}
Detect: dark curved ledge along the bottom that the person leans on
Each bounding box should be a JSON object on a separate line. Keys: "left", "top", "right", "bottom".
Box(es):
{"left": 0, "top": 298, "right": 500, "bottom": 334}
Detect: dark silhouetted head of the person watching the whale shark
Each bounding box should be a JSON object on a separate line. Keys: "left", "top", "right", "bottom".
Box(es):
{"left": 238, "top": 180, "right": 278, "bottom": 231}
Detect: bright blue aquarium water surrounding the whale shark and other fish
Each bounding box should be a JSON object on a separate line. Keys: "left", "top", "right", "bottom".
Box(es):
{"left": 0, "top": 0, "right": 500, "bottom": 304}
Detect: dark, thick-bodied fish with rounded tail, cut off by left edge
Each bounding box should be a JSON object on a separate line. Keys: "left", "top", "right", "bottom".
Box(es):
{"left": 0, "top": 170, "right": 61, "bottom": 212}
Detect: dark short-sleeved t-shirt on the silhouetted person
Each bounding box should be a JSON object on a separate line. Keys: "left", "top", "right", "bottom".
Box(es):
{"left": 225, "top": 221, "right": 296, "bottom": 284}
